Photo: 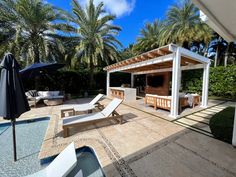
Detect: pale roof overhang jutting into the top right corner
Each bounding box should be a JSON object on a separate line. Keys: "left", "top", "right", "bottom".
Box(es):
{"left": 192, "top": 0, "right": 236, "bottom": 42}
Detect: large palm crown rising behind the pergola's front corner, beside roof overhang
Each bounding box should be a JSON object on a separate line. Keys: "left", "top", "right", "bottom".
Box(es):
{"left": 160, "top": 0, "right": 212, "bottom": 48}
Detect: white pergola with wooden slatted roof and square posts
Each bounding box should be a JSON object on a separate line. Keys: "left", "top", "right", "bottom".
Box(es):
{"left": 104, "top": 44, "right": 210, "bottom": 118}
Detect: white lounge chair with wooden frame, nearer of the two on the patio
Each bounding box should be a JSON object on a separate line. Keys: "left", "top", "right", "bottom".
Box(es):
{"left": 62, "top": 98, "right": 123, "bottom": 138}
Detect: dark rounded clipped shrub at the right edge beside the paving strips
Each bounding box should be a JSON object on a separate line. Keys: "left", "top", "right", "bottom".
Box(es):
{"left": 209, "top": 107, "right": 235, "bottom": 144}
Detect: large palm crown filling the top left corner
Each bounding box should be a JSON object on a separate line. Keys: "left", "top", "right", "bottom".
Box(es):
{"left": 0, "top": 0, "right": 72, "bottom": 62}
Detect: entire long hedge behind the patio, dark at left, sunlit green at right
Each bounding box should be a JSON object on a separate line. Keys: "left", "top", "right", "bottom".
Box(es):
{"left": 23, "top": 66, "right": 236, "bottom": 99}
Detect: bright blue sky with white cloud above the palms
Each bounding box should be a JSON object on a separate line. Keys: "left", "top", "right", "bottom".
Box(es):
{"left": 47, "top": 0, "right": 176, "bottom": 47}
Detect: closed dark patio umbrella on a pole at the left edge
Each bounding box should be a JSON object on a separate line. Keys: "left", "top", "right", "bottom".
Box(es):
{"left": 0, "top": 53, "right": 30, "bottom": 161}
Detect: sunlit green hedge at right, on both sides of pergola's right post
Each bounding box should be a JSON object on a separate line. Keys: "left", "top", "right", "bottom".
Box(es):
{"left": 182, "top": 65, "right": 236, "bottom": 99}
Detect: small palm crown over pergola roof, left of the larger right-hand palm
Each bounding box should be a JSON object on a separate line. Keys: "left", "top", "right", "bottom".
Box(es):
{"left": 135, "top": 20, "right": 163, "bottom": 53}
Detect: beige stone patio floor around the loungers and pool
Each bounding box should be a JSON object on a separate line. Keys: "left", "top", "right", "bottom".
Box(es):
{"left": 0, "top": 99, "right": 236, "bottom": 177}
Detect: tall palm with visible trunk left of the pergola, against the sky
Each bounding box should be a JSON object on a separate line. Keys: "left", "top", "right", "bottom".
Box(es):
{"left": 70, "top": 0, "right": 122, "bottom": 87}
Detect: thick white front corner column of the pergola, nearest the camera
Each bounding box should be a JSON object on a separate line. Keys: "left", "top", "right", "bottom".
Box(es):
{"left": 170, "top": 47, "right": 181, "bottom": 118}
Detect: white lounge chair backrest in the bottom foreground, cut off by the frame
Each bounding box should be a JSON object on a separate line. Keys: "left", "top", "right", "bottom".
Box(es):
{"left": 27, "top": 142, "right": 77, "bottom": 177}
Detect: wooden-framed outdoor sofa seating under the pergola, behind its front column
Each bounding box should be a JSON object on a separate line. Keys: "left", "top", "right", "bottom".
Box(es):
{"left": 144, "top": 93, "right": 200, "bottom": 112}
